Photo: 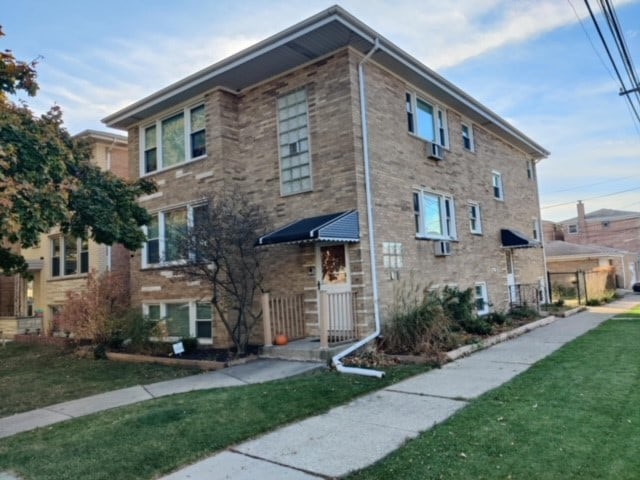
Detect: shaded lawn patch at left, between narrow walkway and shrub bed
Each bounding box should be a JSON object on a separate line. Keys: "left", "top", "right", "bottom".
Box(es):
{"left": 0, "top": 342, "right": 200, "bottom": 417}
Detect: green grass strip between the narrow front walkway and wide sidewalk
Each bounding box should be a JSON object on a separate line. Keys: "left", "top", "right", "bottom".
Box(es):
{"left": 0, "top": 366, "right": 425, "bottom": 480}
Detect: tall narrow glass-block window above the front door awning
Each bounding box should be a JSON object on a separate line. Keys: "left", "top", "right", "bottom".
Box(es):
{"left": 277, "top": 89, "right": 312, "bottom": 195}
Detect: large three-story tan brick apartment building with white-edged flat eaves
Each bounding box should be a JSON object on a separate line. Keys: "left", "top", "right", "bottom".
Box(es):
{"left": 104, "top": 6, "right": 548, "bottom": 346}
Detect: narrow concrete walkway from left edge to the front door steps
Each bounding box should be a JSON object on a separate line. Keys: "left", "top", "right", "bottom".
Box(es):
{"left": 0, "top": 360, "right": 324, "bottom": 438}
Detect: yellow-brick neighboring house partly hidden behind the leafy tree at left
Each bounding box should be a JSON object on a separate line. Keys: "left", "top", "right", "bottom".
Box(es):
{"left": 16, "top": 130, "right": 130, "bottom": 331}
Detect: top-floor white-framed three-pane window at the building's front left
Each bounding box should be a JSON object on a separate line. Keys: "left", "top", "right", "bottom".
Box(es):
{"left": 141, "top": 105, "right": 207, "bottom": 174}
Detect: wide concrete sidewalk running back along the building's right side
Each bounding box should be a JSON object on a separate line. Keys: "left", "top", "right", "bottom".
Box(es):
{"left": 163, "top": 295, "right": 640, "bottom": 480}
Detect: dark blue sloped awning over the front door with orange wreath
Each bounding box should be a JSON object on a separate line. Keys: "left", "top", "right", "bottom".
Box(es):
{"left": 256, "top": 210, "right": 360, "bottom": 245}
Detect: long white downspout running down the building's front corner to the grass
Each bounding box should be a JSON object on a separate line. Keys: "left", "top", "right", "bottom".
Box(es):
{"left": 331, "top": 38, "right": 384, "bottom": 378}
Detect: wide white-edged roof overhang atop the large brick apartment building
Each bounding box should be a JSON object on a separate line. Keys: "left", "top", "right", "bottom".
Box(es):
{"left": 102, "top": 6, "right": 549, "bottom": 160}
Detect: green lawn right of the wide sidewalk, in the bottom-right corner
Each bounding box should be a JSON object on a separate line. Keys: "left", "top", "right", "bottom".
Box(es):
{"left": 349, "top": 307, "right": 640, "bottom": 480}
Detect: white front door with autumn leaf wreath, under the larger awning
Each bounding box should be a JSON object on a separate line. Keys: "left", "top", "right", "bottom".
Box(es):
{"left": 316, "top": 244, "right": 354, "bottom": 337}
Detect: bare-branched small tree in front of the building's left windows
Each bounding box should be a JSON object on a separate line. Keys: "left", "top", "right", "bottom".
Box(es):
{"left": 178, "top": 192, "right": 266, "bottom": 355}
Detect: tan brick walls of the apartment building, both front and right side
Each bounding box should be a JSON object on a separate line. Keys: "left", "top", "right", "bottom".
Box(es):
{"left": 129, "top": 49, "right": 544, "bottom": 343}
